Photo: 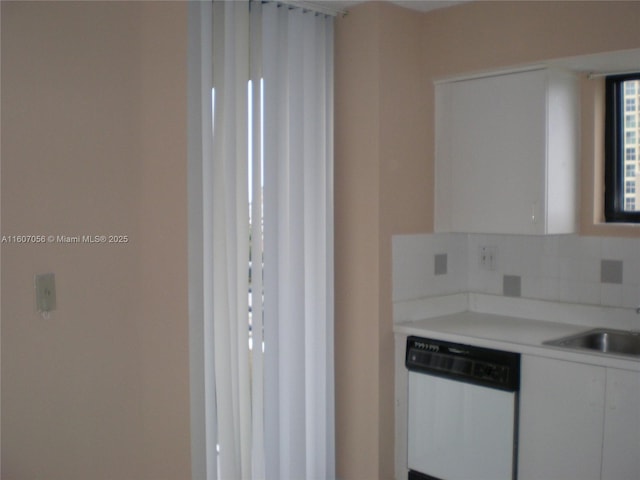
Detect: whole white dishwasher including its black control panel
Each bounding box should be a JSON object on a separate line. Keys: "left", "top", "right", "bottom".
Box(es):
{"left": 405, "top": 337, "right": 520, "bottom": 480}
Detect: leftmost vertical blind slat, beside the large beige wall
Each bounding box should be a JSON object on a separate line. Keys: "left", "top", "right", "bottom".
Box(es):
{"left": 187, "top": 2, "right": 218, "bottom": 480}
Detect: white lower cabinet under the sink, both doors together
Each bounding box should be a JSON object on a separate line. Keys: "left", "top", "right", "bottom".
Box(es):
{"left": 518, "top": 355, "right": 640, "bottom": 480}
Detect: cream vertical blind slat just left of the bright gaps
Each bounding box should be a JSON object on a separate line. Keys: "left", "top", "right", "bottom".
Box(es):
{"left": 210, "top": 2, "right": 251, "bottom": 479}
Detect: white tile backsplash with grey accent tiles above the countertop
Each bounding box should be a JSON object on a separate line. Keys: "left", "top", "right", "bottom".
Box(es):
{"left": 393, "top": 233, "right": 640, "bottom": 308}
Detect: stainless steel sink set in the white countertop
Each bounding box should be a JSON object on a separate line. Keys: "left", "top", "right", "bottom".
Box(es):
{"left": 543, "top": 328, "right": 640, "bottom": 357}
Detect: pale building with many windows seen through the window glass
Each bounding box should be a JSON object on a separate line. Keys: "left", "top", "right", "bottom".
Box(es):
{"left": 622, "top": 80, "right": 640, "bottom": 212}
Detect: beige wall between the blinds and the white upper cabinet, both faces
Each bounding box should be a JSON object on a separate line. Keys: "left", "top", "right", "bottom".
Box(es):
{"left": 335, "top": 5, "right": 432, "bottom": 479}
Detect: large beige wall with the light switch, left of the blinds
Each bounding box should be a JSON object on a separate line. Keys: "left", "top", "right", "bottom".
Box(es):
{"left": 1, "top": 1, "right": 190, "bottom": 480}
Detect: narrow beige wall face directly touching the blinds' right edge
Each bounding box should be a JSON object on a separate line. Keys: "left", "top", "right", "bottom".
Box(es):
{"left": 335, "top": 8, "right": 381, "bottom": 479}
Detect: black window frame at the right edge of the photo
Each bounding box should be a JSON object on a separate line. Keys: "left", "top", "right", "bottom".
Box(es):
{"left": 604, "top": 72, "right": 640, "bottom": 223}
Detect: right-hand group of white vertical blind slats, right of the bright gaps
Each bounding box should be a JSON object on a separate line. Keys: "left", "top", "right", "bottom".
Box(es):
{"left": 262, "top": 3, "right": 335, "bottom": 479}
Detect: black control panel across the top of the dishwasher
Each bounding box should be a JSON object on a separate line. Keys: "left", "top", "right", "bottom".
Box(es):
{"left": 405, "top": 336, "right": 520, "bottom": 391}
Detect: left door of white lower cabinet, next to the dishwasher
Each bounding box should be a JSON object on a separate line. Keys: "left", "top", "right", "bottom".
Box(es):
{"left": 518, "top": 355, "right": 605, "bottom": 480}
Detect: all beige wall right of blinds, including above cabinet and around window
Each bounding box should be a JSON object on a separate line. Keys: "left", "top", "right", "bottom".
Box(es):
{"left": 335, "top": 1, "right": 640, "bottom": 480}
